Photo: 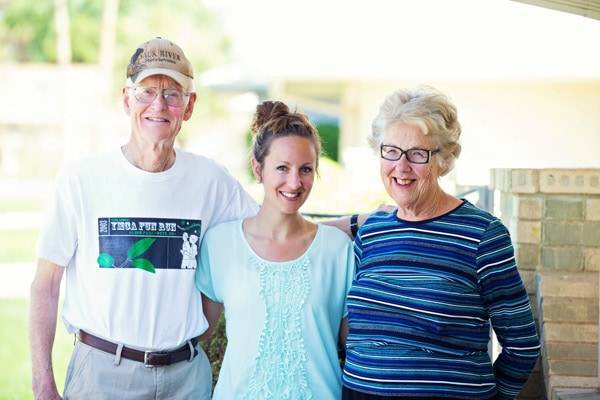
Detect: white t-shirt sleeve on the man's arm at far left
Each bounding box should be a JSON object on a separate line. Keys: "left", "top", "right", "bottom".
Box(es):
{"left": 37, "top": 166, "right": 80, "bottom": 267}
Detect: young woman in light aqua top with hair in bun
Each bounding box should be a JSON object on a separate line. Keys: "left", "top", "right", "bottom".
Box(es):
{"left": 196, "top": 102, "right": 354, "bottom": 400}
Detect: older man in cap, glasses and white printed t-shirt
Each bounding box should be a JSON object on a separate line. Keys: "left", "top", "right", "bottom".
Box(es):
{"left": 30, "top": 38, "right": 256, "bottom": 399}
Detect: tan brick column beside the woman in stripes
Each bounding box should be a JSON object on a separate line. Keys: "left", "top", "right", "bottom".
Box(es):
{"left": 491, "top": 169, "right": 600, "bottom": 398}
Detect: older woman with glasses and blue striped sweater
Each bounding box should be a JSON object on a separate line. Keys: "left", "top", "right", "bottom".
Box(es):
{"left": 343, "top": 88, "right": 539, "bottom": 399}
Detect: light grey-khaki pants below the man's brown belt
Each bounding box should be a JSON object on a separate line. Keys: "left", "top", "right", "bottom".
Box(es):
{"left": 63, "top": 341, "right": 212, "bottom": 400}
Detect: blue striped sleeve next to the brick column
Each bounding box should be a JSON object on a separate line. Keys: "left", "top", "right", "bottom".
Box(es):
{"left": 477, "top": 219, "right": 540, "bottom": 399}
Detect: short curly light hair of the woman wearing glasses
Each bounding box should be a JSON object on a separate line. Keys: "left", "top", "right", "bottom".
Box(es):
{"left": 368, "top": 86, "right": 461, "bottom": 176}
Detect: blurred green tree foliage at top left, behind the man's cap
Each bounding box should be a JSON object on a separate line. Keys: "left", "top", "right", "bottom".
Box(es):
{"left": 0, "top": 0, "right": 230, "bottom": 69}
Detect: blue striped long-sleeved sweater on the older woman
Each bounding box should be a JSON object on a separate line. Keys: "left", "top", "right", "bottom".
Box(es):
{"left": 343, "top": 201, "right": 540, "bottom": 399}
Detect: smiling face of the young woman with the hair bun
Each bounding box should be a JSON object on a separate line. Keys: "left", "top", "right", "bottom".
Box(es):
{"left": 252, "top": 136, "right": 317, "bottom": 214}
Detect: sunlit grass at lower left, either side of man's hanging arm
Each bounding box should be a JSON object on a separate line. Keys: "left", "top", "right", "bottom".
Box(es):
{"left": 0, "top": 299, "right": 73, "bottom": 400}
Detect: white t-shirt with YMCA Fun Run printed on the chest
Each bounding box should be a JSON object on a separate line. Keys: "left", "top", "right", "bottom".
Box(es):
{"left": 38, "top": 150, "right": 257, "bottom": 350}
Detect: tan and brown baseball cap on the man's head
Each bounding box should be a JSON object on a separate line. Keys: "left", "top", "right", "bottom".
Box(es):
{"left": 127, "top": 37, "right": 195, "bottom": 92}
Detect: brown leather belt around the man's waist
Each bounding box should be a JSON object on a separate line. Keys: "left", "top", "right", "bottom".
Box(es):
{"left": 79, "top": 330, "right": 198, "bottom": 367}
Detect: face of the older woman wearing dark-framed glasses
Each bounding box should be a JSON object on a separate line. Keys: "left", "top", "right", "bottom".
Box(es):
{"left": 380, "top": 122, "right": 439, "bottom": 208}
